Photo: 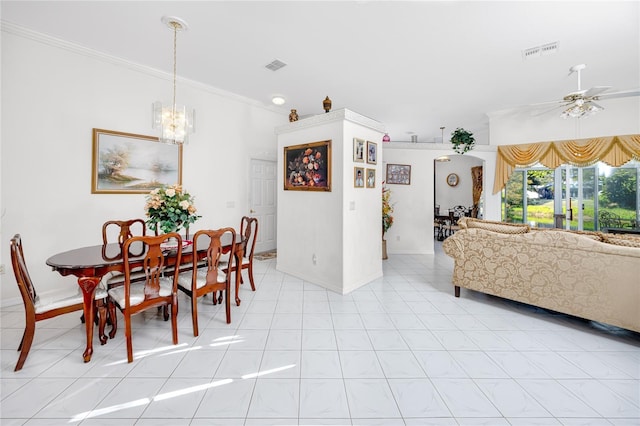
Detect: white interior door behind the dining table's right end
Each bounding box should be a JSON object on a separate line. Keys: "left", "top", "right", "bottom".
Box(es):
{"left": 249, "top": 159, "right": 278, "bottom": 253}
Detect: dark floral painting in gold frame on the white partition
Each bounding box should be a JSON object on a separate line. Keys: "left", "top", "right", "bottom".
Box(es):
{"left": 284, "top": 140, "right": 331, "bottom": 191}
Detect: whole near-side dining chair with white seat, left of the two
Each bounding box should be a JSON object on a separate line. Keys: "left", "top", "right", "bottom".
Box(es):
{"left": 108, "top": 232, "right": 182, "bottom": 362}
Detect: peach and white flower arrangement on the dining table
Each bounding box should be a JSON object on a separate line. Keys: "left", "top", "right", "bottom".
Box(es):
{"left": 144, "top": 184, "right": 202, "bottom": 233}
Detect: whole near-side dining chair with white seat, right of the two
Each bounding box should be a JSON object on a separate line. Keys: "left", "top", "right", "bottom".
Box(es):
{"left": 178, "top": 228, "right": 236, "bottom": 336}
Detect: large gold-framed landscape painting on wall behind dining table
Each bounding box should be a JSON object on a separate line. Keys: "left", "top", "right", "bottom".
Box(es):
{"left": 91, "top": 129, "right": 182, "bottom": 194}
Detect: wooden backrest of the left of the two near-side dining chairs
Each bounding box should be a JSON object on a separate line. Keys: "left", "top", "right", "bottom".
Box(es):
{"left": 122, "top": 232, "right": 182, "bottom": 309}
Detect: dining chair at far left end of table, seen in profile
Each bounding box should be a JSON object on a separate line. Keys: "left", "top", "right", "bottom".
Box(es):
{"left": 11, "top": 234, "right": 107, "bottom": 371}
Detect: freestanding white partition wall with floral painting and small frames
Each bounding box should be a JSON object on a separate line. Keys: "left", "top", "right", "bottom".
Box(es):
{"left": 277, "top": 109, "right": 382, "bottom": 294}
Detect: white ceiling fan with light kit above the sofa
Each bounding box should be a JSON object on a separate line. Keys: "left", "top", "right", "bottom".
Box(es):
{"left": 560, "top": 64, "right": 640, "bottom": 119}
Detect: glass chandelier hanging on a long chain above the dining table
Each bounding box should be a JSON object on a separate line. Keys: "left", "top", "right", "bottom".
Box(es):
{"left": 153, "top": 16, "right": 195, "bottom": 144}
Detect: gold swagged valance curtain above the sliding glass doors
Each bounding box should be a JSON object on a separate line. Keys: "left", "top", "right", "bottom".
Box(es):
{"left": 493, "top": 135, "right": 640, "bottom": 194}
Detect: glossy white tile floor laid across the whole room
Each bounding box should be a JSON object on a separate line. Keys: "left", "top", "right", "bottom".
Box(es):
{"left": 0, "top": 245, "right": 640, "bottom": 426}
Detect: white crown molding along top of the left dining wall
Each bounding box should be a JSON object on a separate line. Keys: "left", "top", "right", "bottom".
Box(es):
{"left": 0, "top": 19, "right": 286, "bottom": 115}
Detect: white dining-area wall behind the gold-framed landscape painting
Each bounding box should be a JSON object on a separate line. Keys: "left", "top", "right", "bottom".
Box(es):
{"left": 0, "top": 27, "right": 288, "bottom": 305}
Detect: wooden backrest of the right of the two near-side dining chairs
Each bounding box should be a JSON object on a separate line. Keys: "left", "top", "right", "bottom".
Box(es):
{"left": 193, "top": 228, "right": 236, "bottom": 284}
